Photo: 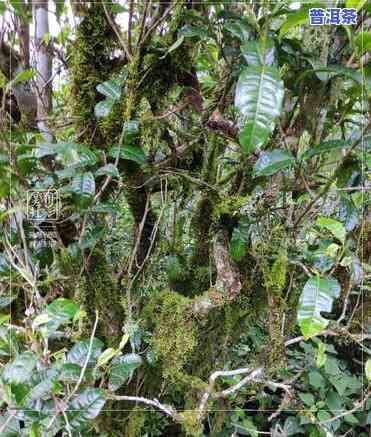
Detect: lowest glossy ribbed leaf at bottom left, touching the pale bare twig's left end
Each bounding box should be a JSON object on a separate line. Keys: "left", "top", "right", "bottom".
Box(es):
{"left": 67, "top": 387, "right": 106, "bottom": 431}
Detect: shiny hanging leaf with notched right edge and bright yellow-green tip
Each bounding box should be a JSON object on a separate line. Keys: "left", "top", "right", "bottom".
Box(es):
{"left": 298, "top": 276, "right": 340, "bottom": 340}
